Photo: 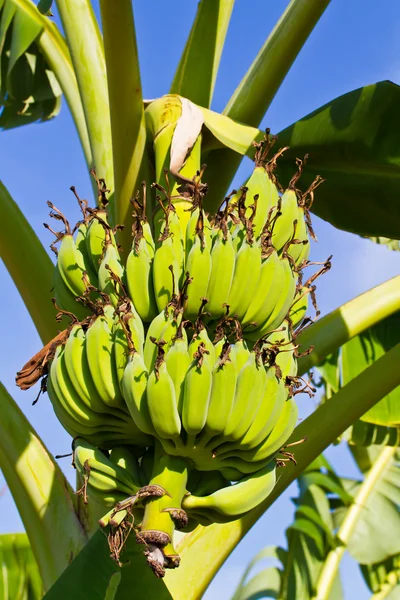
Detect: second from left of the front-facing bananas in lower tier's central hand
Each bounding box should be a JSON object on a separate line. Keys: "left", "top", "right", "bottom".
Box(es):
{"left": 146, "top": 354, "right": 181, "bottom": 440}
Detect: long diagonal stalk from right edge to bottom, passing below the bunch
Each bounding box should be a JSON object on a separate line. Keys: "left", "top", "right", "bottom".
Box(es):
{"left": 166, "top": 344, "right": 400, "bottom": 600}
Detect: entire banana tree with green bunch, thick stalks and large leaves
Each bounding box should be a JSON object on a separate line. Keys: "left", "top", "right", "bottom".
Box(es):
{"left": 0, "top": 0, "right": 400, "bottom": 599}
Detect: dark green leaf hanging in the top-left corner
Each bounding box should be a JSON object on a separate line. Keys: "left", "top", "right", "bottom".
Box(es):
{"left": 0, "top": 0, "right": 61, "bottom": 129}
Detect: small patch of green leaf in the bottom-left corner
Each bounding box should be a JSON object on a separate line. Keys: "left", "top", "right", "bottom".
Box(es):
{"left": 0, "top": 533, "right": 43, "bottom": 600}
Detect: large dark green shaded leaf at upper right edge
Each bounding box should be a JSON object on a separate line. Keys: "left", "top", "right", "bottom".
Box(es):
{"left": 278, "top": 81, "right": 400, "bottom": 239}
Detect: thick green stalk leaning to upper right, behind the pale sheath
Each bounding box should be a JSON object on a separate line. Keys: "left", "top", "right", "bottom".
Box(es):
{"left": 206, "top": 0, "right": 330, "bottom": 211}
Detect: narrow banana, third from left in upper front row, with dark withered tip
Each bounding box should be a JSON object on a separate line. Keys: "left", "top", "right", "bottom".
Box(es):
{"left": 185, "top": 210, "right": 211, "bottom": 321}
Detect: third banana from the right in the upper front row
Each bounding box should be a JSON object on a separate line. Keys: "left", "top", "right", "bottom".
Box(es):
{"left": 228, "top": 239, "right": 261, "bottom": 320}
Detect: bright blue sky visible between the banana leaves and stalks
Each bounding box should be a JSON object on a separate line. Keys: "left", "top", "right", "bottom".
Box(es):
{"left": 0, "top": 0, "right": 400, "bottom": 600}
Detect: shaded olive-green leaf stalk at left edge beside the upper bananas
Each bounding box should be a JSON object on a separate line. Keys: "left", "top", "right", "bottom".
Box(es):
{"left": 0, "top": 182, "right": 59, "bottom": 344}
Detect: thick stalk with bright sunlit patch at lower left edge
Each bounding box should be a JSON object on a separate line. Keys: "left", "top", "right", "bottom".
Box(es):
{"left": 0, "top": 384, "right": 87, "bottom": 589}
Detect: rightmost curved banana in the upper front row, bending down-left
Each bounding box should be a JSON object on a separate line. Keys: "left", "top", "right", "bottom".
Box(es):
{"left": 245, "top": 257, "right": 296, "bottom": 340}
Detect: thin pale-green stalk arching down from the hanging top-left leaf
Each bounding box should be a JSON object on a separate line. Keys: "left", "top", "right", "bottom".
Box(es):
{"left": 13, "top": 0, "right": 93, "bottom": 168}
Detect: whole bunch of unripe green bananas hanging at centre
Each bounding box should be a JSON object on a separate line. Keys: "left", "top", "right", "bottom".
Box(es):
{"left": 17, "top": 140, "right": 330, "bottom": 575}
